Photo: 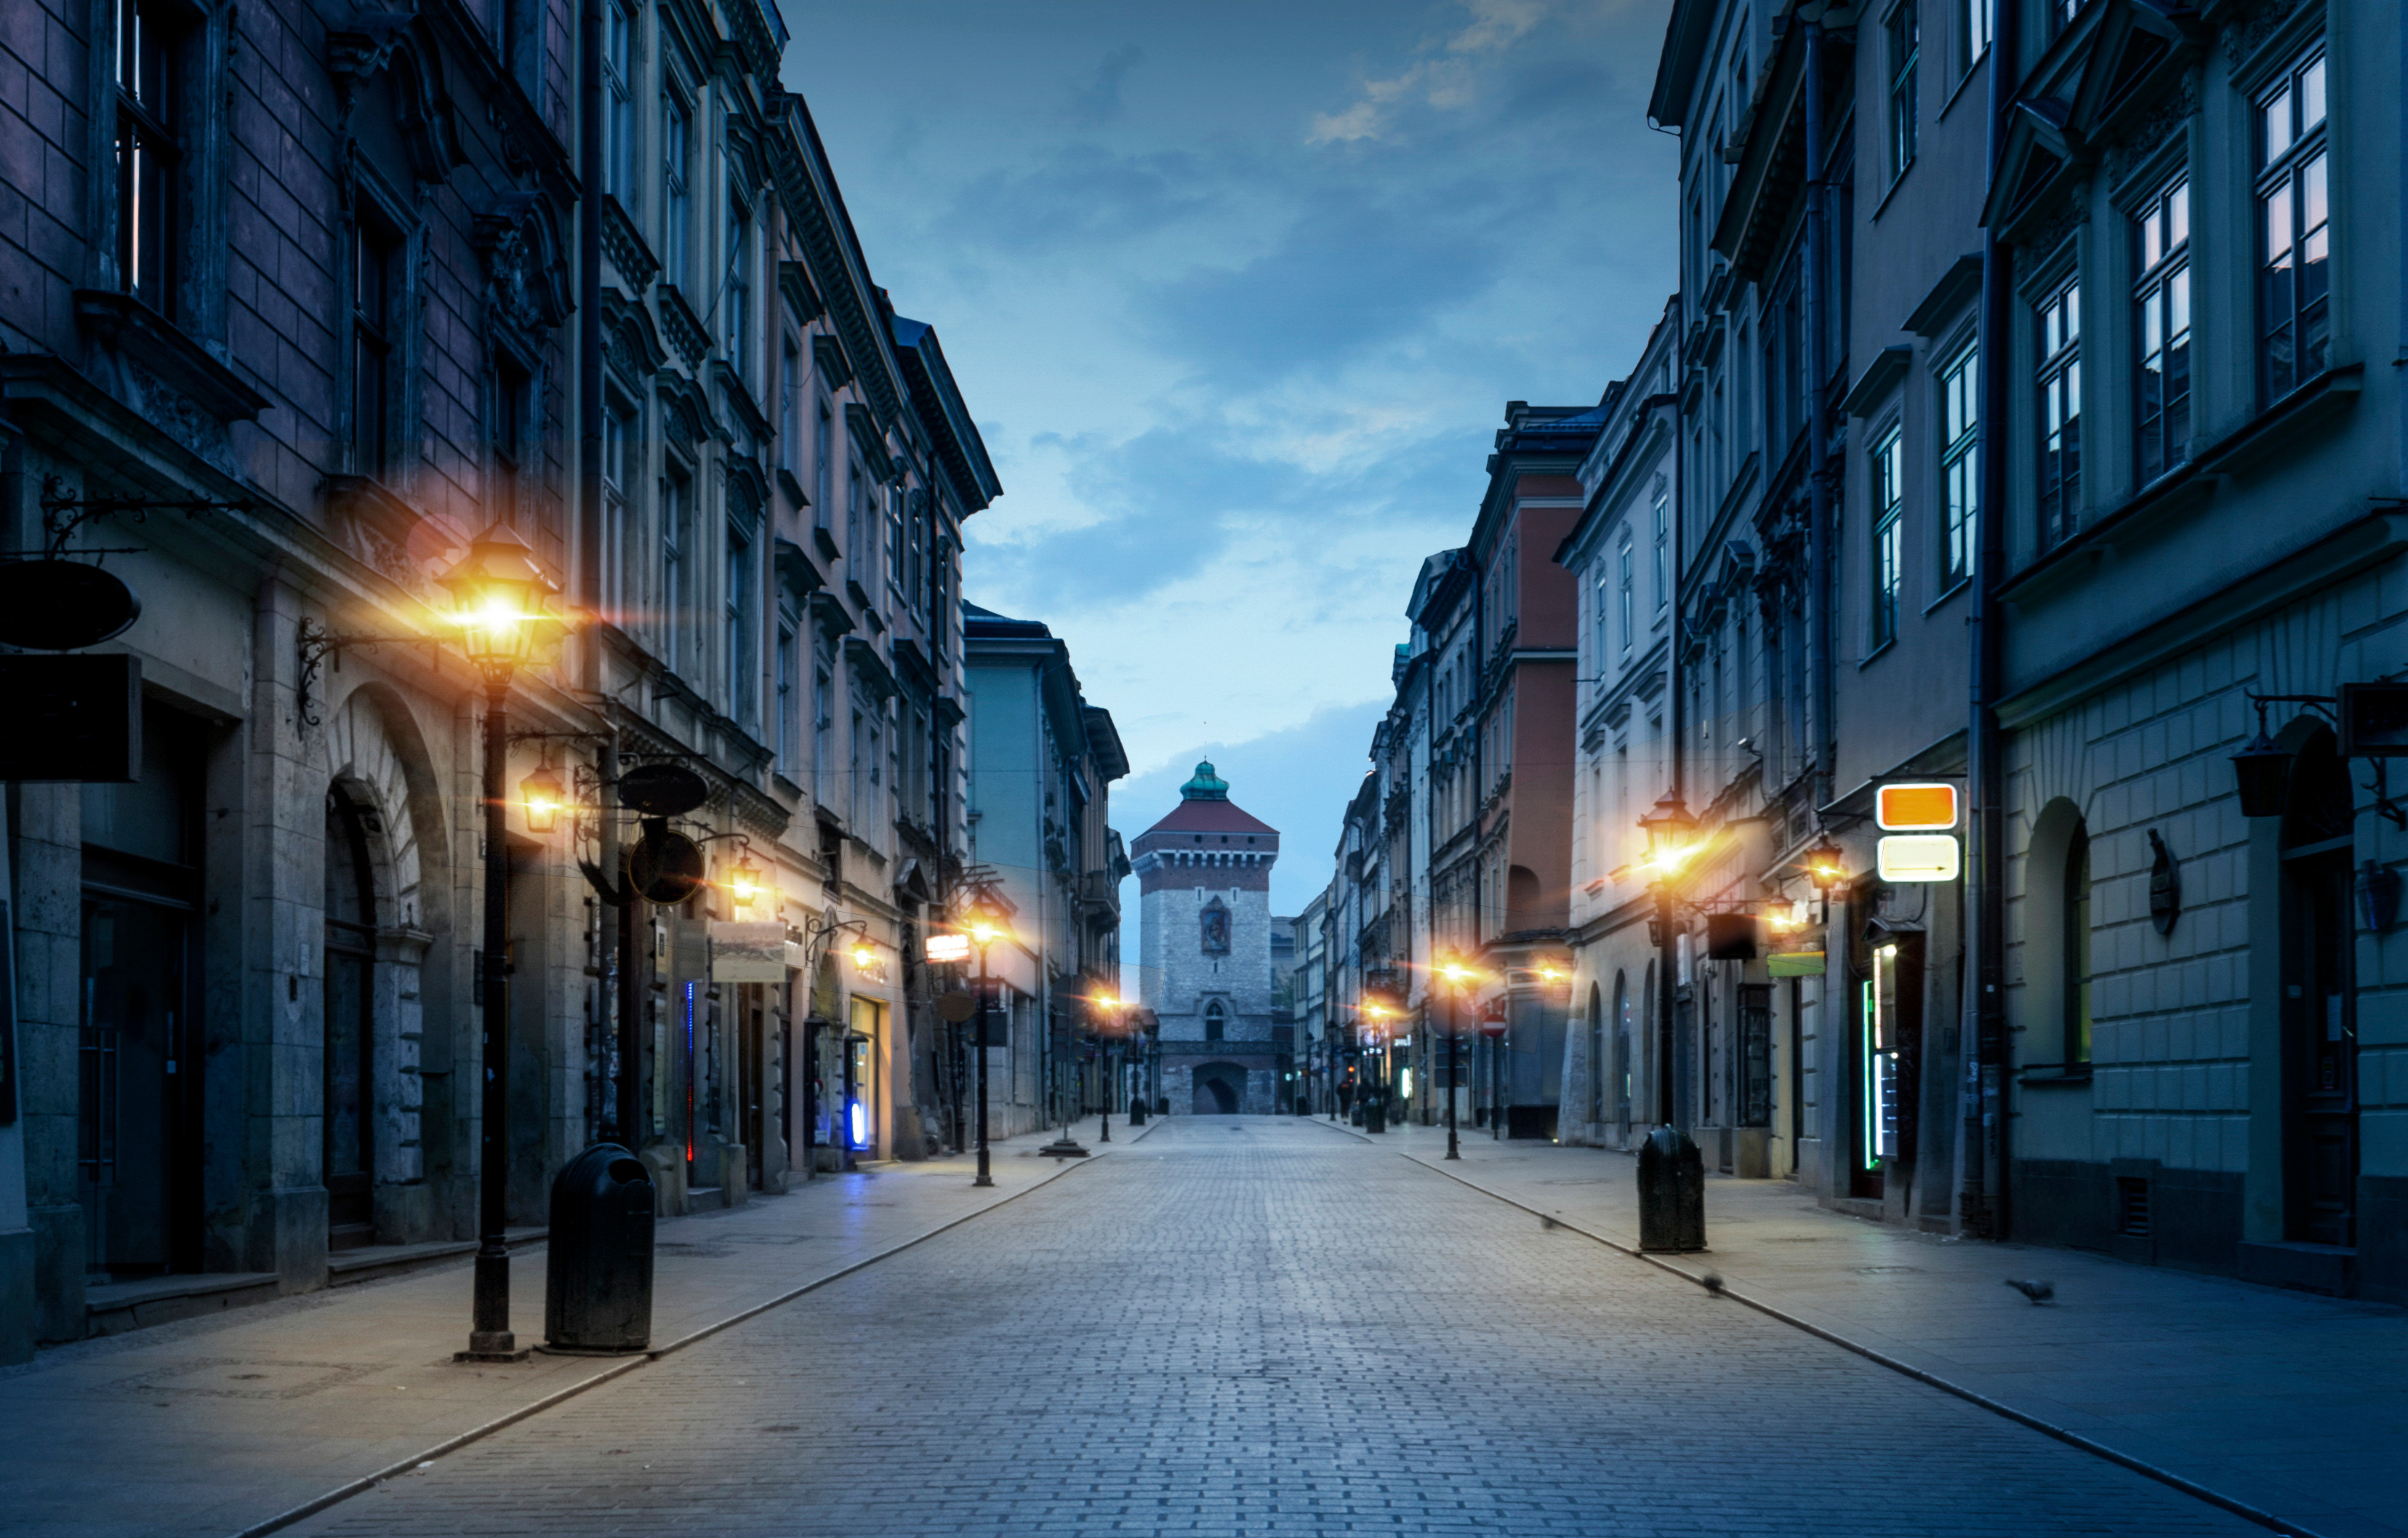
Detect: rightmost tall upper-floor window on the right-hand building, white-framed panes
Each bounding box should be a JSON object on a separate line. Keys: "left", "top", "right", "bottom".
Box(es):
{"left": 2256, "top": 46, "right": 2333, "bottom": 402}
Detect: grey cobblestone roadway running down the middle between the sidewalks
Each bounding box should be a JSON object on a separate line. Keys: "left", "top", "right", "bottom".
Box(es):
{"left": 294, "top": 1117, "right": 2261, "bottom": 1538}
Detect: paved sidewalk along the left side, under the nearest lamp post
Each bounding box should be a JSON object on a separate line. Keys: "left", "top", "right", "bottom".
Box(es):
{"left": 0, "top": 1119, "right": 1147, "bottom": 1538}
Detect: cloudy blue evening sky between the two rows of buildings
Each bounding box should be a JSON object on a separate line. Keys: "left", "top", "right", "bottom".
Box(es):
{"left": 785, "top": 0, "right": 1676, "bottom": 987}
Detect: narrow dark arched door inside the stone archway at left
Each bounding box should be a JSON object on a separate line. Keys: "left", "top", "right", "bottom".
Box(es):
{"left": 320, "top": 787, "right": 376, "bottom": 1249}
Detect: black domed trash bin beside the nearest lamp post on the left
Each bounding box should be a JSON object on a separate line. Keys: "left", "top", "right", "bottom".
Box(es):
{"left": 545, "top": 1143, "right": 653, "bottom": 1353}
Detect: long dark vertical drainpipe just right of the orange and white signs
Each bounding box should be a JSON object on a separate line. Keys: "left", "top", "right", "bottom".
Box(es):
{"left": 1958, "top": 0, "right": 2020, "bottom": 1240}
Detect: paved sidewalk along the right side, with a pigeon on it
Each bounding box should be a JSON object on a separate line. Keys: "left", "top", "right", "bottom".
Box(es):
{"left": 1320, "top": 1117, "right": 2408, "bottom": 1538}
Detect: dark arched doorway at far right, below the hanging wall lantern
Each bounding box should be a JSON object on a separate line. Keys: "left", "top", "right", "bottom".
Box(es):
{"left": 2280, "top": 729, "right": 2357, "bottom": 1244}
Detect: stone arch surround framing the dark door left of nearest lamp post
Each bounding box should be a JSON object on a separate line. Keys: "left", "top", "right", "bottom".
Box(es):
{"left": 320, "top": 684, "right": 450, "bottom": 1242}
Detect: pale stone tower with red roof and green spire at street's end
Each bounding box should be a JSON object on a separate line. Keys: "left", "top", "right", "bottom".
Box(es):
{"left": 1129, "top": 763, "right": 1279, "bottom": 1117}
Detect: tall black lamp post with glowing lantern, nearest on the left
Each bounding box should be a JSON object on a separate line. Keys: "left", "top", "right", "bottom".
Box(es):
{"left": 443, "top": 522, "right": 563, "bottom": 1362}
